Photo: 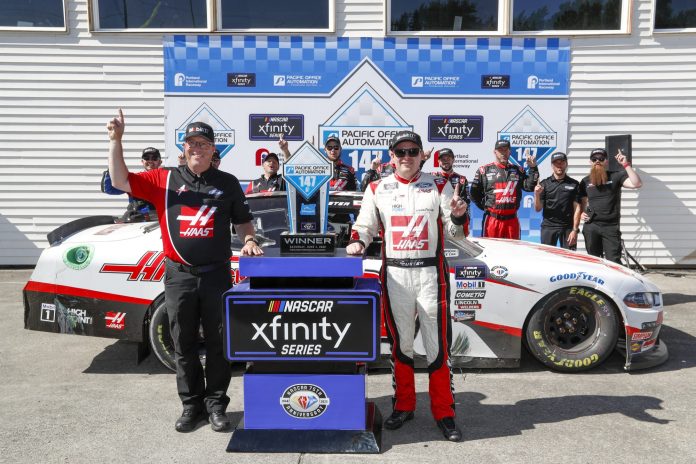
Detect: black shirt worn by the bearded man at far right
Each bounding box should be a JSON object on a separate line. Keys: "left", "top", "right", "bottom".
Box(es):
{"left": 580, "top": 171, "right": 628, "bottom": 224}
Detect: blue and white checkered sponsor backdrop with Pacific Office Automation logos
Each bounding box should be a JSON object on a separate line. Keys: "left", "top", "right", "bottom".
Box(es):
{"left": 164, "top": 35, "right": 570, "bottom": 241}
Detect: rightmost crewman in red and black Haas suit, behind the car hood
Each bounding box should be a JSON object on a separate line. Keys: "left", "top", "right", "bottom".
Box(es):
{"left": 470, "top": 140, "right": 539, "bottom": 240}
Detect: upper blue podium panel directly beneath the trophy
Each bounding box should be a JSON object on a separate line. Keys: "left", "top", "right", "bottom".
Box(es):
{"left": 239, "top": 248, "right": 363, "bottom": 277}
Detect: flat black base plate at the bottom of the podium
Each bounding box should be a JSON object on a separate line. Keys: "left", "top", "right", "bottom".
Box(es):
{"left": 227, "top": 402, "right": 382, "bottom": 454}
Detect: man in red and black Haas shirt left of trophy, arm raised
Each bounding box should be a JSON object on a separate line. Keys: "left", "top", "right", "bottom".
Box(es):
{"left": 107, "top": 110, "right": 263, "bottom": 432}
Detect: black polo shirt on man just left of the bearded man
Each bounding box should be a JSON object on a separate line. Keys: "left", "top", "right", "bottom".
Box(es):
{"left": 540, "top": 176, "right": 580, "bottom": 228}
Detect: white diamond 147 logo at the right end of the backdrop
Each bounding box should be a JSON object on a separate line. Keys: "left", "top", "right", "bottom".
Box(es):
{"left": 498, "top": 105, "right": 558, "bottom": 168}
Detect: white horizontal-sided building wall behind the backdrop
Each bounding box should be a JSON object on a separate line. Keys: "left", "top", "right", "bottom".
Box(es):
{"left": 0, "top": 0, "right": 696, "bottom": 266}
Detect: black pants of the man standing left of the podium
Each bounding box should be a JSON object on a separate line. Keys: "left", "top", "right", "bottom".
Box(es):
{"left": 164, "top": 260, "right": 232, "bottom": 412}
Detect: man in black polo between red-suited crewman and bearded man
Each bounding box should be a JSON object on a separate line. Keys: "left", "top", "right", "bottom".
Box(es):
{"left": 534, "top": 151, "right": 582, "bottom": 250}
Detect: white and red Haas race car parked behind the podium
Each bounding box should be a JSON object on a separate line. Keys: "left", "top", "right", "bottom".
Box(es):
{"left": 23, "top": 192, "right": 668, "bottom": 372}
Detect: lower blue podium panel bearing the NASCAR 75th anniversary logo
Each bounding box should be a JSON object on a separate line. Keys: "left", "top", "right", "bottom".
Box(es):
{"left": 244, "top": 374, "right": 366, "bottom": 430}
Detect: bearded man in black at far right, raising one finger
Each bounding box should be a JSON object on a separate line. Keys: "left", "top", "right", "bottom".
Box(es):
{"left": 580, "top": 148, "right": 643, "bottom": 264}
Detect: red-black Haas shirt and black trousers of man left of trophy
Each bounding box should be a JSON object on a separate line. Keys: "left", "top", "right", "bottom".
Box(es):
{"left": 128, "top": 166, "right": 253, "bottom": 413}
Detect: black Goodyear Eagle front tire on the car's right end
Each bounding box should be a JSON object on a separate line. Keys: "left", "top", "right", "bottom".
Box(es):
{"left": 525, "top": 287, "right": 619, "bottom": 372}
